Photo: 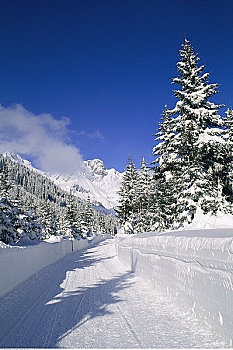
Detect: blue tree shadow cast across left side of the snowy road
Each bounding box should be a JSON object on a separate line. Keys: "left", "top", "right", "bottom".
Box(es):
{"left": 0, "top": 242, "right": 135, "bottom": 348}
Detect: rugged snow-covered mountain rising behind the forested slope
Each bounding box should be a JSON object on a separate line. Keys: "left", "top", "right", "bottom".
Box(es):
{"left": 5, "top": 152, "right": 123, "bottom": 209}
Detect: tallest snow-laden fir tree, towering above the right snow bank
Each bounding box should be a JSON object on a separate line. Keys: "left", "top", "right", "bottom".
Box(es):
{"left": 154, "top": 39, "right": 231, "bottom": 227}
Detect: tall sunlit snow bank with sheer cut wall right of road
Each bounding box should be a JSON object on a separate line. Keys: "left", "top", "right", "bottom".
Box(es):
{"left": 118, "top": 229, "right": 233, "bottom": 340}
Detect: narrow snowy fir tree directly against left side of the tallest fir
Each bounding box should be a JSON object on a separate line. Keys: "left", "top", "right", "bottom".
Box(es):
{"left": 149, "top": 106, "right": 178, "bottom": 231}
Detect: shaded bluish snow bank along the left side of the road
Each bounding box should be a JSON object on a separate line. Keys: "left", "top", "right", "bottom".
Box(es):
{"left": 0, "top": 234, "right": 109, "bottom": 296}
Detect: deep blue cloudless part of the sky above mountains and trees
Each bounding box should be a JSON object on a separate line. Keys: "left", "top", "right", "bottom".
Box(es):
{"left": 0, "top": 0, "right": 233, "bottom": 171}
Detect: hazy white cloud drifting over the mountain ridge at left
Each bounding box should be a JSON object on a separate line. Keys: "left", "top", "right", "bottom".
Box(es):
{"left": 0, "top": 105, "right": 83, "bottom": 174}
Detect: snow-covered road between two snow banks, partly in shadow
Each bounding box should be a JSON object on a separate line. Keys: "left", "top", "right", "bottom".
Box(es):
{"left": 0, "top": 240, "right": 228, "bottom": 348}
